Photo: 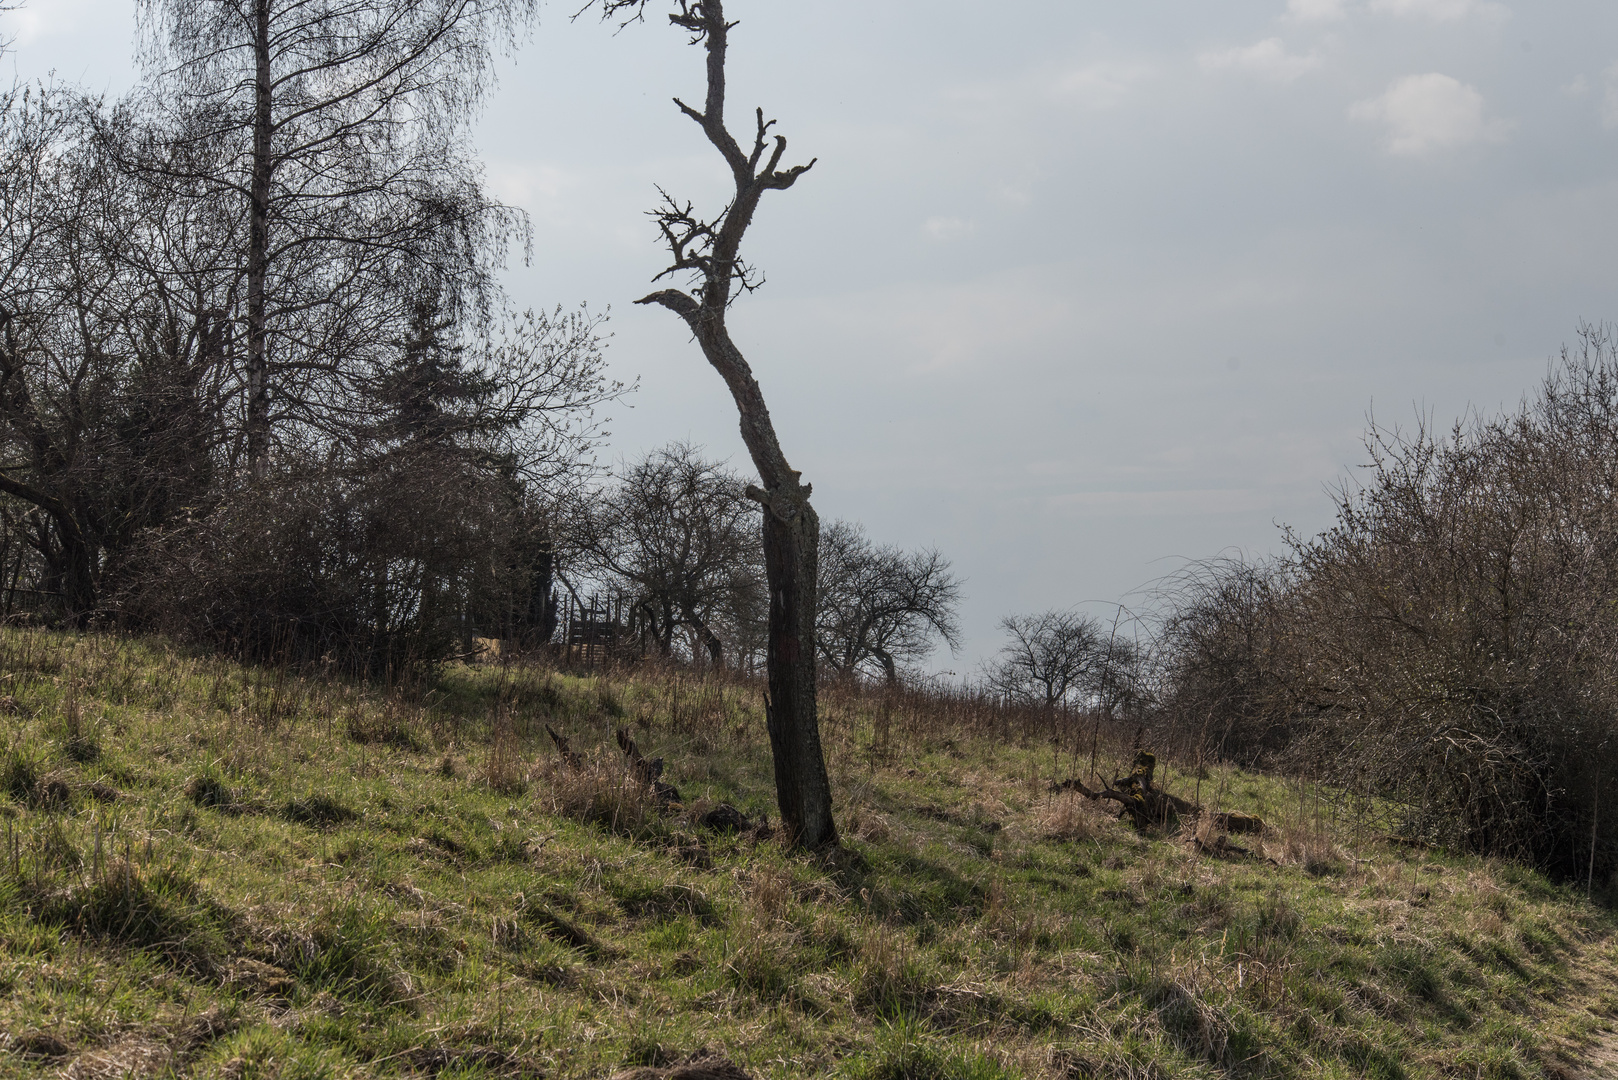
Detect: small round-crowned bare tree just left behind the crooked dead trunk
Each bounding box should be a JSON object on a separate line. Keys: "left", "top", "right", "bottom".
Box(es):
{"left": 582, "top": 442, "right": 764, "bottom": 665}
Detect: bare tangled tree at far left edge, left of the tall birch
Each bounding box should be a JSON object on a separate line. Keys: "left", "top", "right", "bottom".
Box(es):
{"left": 0, "top": 87, "right": 234, "bottom": 620}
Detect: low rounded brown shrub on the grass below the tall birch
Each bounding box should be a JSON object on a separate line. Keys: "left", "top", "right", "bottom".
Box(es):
{"left": 120, "top": 452, "right": 550, "bottom": 675}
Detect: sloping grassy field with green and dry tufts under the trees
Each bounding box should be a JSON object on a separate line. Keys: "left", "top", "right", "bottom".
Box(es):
{"left": 0, "top": 630, "right": 1618, "bottom": 1080}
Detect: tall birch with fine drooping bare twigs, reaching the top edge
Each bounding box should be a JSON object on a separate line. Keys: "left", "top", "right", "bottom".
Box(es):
{"left": 131, "top": 0, "right": 534, "bottom": 476}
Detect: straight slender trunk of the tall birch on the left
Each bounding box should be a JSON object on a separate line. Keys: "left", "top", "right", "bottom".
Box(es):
{"left": 248, "top": 0, "right": 273, "bottom": 479}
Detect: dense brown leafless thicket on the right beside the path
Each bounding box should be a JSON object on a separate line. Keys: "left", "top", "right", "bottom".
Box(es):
{"left": 1165, "top": 329, "right": 1618, "bottom": 878}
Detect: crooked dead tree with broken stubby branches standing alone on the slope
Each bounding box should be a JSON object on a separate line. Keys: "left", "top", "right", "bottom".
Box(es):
{"left": 602, "top": 0, "right": 837, "bottom": 848}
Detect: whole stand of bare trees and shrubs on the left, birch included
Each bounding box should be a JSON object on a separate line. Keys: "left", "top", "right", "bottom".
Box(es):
{"left": 0, "top": 10, "right": 625, "bottom": 670}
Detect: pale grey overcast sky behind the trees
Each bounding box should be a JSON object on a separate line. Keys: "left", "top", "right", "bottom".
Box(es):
{"left": 0, "top": 0, "right": 1618, "bottom": 674}
